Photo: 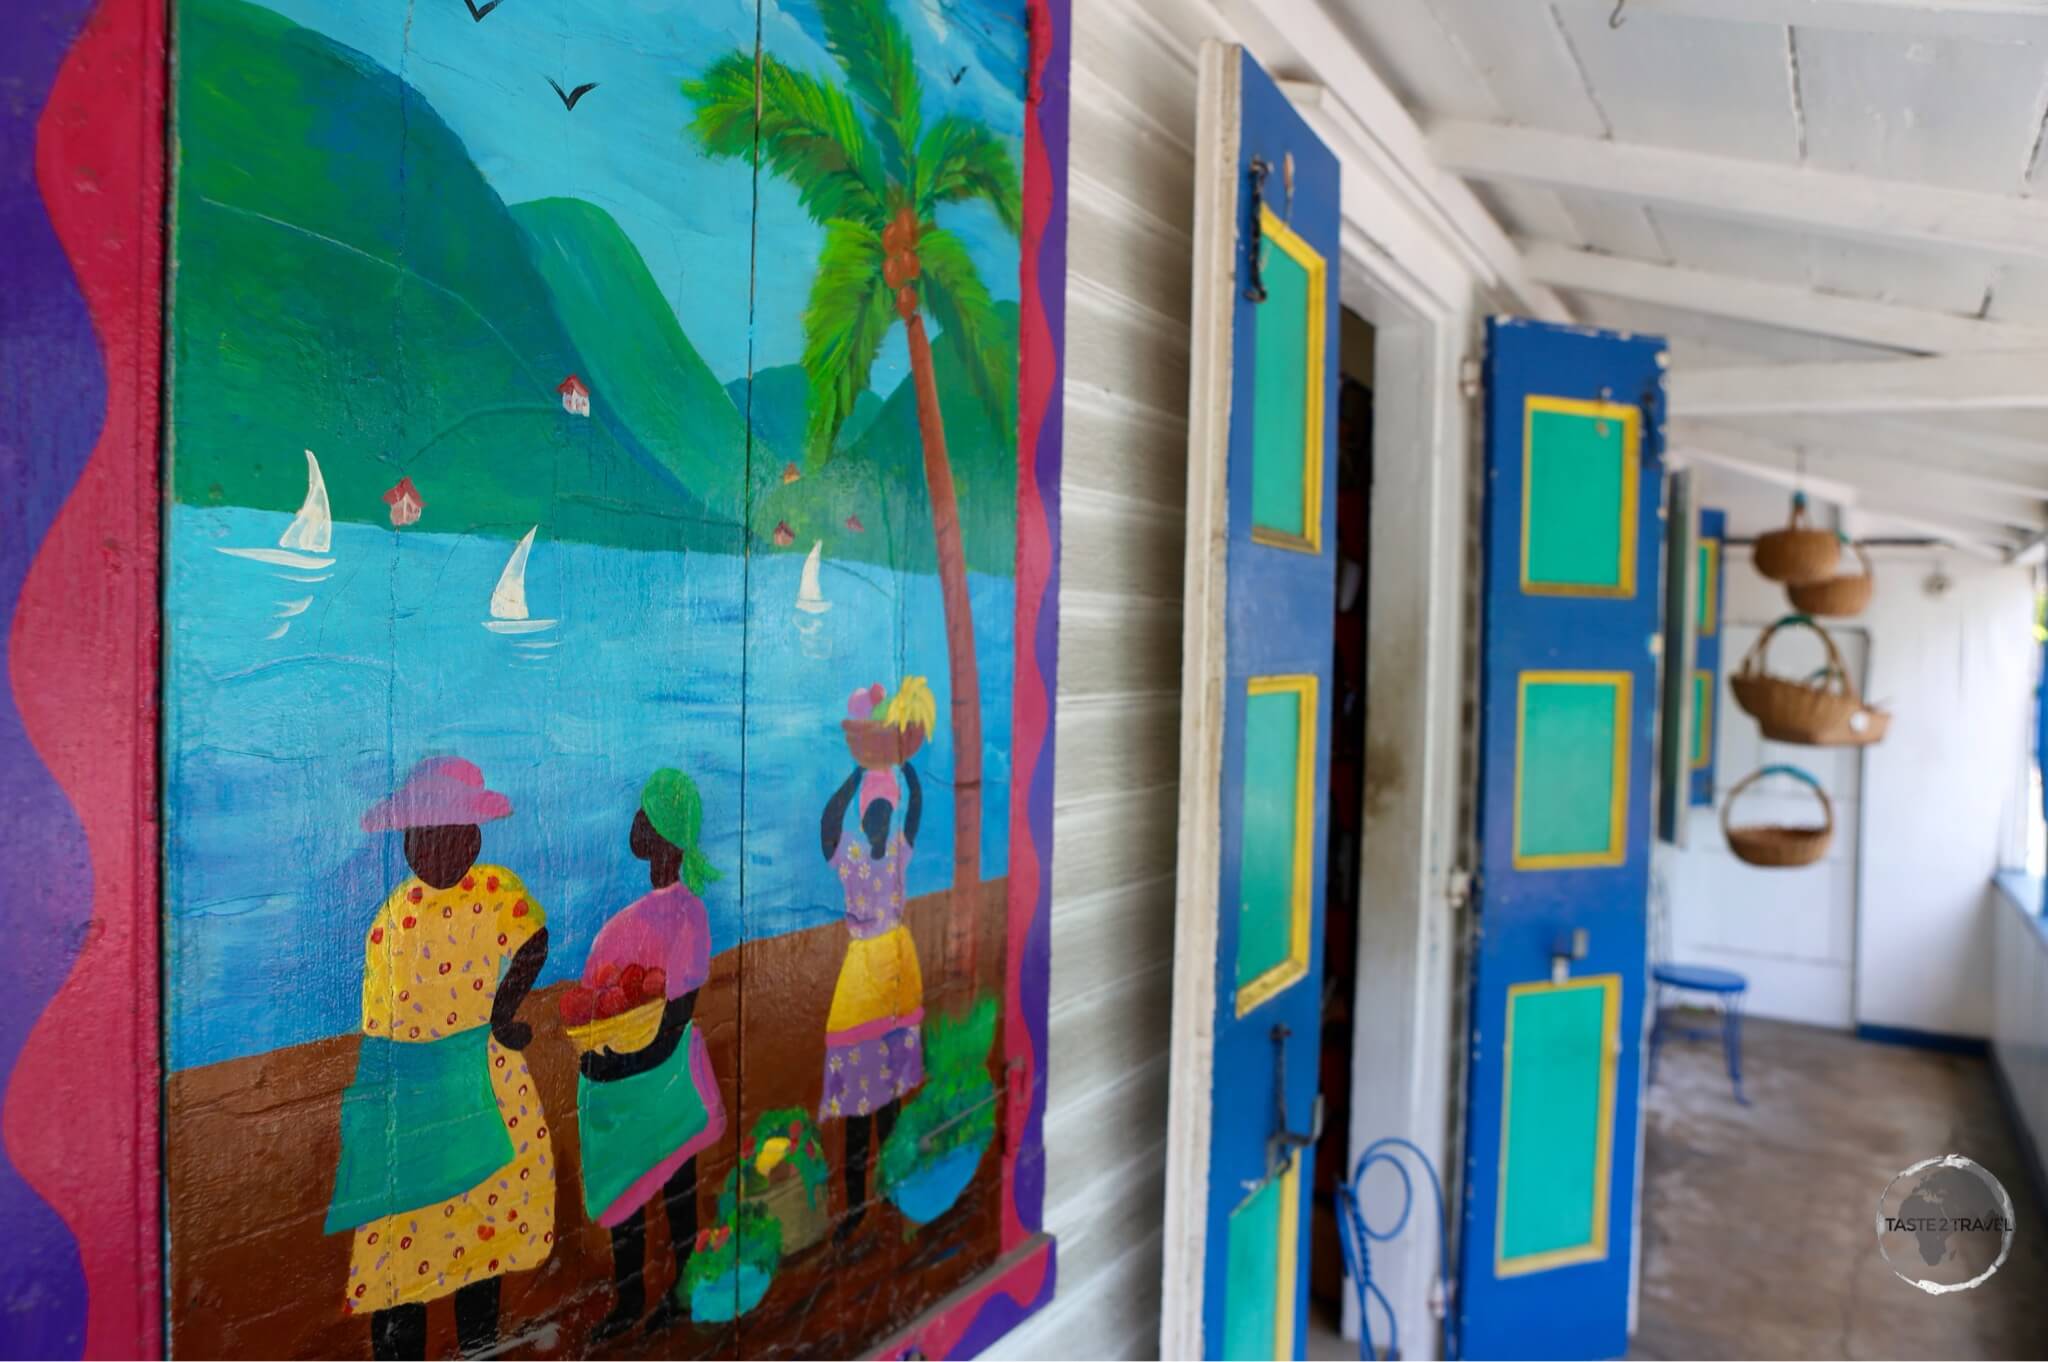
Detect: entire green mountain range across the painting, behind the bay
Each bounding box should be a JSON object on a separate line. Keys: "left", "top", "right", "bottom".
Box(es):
{"left": 170, "top": 0, "right": 1018, "bottom": 576}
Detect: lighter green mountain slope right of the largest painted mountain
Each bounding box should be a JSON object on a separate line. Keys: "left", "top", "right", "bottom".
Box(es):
{"left": 512, "top": 199, "right": 753, "bottom": 522}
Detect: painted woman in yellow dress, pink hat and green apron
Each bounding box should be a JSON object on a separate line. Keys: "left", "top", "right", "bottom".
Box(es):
{"left": 326, "top": 758, "right": 555, "bottom": 1358}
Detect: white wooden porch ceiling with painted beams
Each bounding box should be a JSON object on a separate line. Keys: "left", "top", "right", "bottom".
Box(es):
{"left": 1321, "top": 0, "right": 2048, "bottom": 553}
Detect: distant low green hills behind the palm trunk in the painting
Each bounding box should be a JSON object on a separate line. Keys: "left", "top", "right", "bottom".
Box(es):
{"left": 748, "top": 303, "right": 1018, "bottom": 576}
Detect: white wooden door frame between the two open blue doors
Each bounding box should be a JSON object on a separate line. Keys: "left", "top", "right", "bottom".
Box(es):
{"left": 1282, "top": 82, "right": 1479, "bottom": 1358}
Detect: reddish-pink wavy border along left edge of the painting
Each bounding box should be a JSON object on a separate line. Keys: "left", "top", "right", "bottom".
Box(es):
{"left": 4, "top": 0, "right": 164, "bottom": 1358}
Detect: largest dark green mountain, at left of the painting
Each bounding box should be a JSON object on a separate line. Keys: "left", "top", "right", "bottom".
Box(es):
{"left": 170, "top": 0, "right": 743, "bottom": 547}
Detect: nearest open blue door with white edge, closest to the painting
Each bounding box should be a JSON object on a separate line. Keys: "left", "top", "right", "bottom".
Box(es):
{"left": 1161, "top": 43, "right": 1339, "bottom": 1358}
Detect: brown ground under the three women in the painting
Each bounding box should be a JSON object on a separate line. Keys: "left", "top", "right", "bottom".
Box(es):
{"left": 166, "top": 879, "right": 1008, "bottom": 1358}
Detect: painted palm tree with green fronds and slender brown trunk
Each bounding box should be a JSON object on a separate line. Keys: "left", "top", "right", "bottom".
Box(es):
{"left": 684, "top": 0, "right": 1024, "bottom": 913}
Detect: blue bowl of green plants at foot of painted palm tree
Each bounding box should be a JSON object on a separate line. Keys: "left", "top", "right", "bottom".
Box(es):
{"left": 881, "top": 997, "right": 999, "bottom": 1225}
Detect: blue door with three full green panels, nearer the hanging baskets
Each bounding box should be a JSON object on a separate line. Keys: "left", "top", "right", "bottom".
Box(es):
{"left": 1458, "top": 320, "right": 1663, "bottom": 1358}
